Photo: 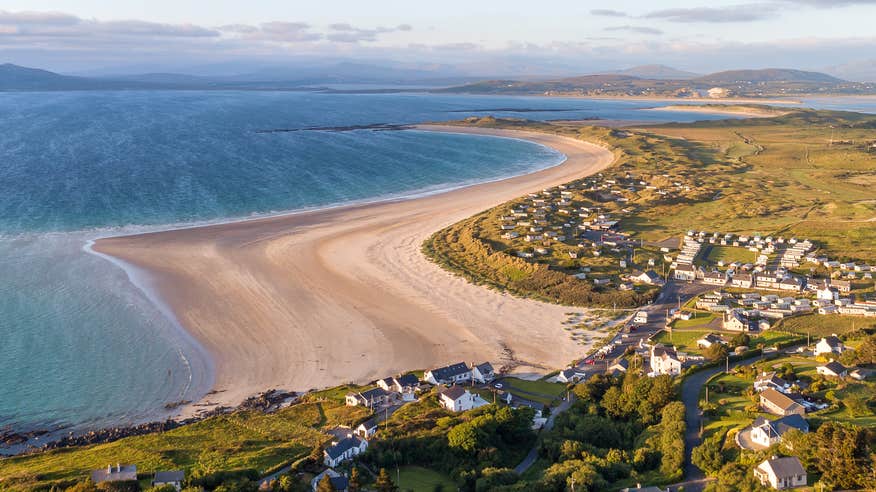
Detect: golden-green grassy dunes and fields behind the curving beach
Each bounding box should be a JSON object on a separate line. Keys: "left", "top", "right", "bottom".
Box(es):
{"left": 424, "top": 110, "right": 876, "bottom": 306}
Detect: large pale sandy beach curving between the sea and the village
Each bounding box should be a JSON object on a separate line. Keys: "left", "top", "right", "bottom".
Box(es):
{"left": 94, "top": 127, "right": 614, "bottom": 414}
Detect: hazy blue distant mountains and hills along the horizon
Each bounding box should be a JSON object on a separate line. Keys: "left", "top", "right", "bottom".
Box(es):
{"left": 0, "top": 63, "right": 876, "bottom": 97}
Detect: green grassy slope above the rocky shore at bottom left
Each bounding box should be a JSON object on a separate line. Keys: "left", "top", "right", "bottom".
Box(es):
{"left": 0, "top": 401, "right": 367, "bottom": 490}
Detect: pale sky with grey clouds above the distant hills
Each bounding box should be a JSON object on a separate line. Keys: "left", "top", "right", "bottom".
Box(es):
{"left": 0, "top": 0, "right": 876, "bottom": 76}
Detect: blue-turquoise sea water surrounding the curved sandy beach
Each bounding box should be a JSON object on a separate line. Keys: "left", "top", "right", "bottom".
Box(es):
{"left": 0, "top": 91, "right": 856, "bottom": 440}
